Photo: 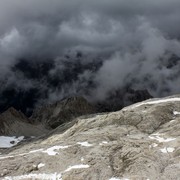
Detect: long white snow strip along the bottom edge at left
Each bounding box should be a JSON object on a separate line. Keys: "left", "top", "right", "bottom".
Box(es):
{"left": 4, "top": 173, "right": 62, "bottom": 180}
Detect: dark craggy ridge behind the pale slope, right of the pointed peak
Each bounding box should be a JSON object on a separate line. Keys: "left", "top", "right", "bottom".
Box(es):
{"left": 31, "top": 97, "right": 95, "bottom": 129}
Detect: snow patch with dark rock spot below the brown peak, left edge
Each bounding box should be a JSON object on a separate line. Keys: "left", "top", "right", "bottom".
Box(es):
{"left": 0, "top": 136, "right": 24, "bottom": 148}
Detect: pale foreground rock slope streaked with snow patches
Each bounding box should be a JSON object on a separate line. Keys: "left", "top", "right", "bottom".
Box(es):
{"left": 0, "top": 95, "right": 180, "bottom": 180}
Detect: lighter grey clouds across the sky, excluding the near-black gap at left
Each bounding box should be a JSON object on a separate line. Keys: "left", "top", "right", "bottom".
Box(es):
{"left": 0, "top": 0, "right": 180, "bottom": 108}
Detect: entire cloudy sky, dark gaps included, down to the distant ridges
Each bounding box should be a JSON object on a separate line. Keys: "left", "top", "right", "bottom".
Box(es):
{"left": 0, "top": 0, "right": 180, "bottom": 113}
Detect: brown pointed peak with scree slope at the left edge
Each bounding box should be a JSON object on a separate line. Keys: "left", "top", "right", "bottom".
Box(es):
{"left": 0, "top": 108, "right": 47, "bottom": 136}
